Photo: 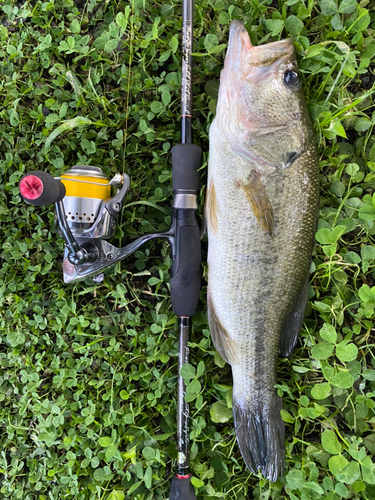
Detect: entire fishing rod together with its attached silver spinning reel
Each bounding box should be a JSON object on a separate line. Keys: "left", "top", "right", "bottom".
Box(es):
{"left": 19, "top": 0, "right": 202, "bottom": 500}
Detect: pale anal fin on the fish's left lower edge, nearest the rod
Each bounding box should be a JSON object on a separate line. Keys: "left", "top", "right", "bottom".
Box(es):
{"left": 207, "top": 292, "right": 239, "bottom": 366}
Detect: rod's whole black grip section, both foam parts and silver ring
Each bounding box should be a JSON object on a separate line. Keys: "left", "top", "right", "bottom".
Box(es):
{"left": 170, "top": 144, "right": 202, "bottom": 317}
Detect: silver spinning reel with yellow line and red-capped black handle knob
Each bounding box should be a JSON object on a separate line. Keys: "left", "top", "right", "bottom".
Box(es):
{"left": 20, "top": 165, "right": 167, "bottom": 283}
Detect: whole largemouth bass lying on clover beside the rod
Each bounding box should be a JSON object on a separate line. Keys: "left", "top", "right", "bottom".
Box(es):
{"left": 205, "top": 20, "right": 319, "bottom": 482}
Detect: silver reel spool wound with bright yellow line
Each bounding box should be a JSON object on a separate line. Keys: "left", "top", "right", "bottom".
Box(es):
{"left": 61, "top": 165, "right": 122, "bottom": 234}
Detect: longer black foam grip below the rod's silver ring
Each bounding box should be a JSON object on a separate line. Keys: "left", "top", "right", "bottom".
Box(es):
{"left": 170, "top": 210, "right": 201, "bottom": 317}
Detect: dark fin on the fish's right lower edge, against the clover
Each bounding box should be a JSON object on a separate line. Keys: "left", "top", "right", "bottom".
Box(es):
{"left": 279, "top": 279, "right": 310, "bottom": 358}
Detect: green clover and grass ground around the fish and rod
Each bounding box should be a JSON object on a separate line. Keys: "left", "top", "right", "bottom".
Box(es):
{"left": 0, "top": 0, "right": 375, "bottom": 500}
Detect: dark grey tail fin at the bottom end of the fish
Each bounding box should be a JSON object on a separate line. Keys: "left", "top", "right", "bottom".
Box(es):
{"left": 233, "top": 394, "right": 285, "bottom": 482}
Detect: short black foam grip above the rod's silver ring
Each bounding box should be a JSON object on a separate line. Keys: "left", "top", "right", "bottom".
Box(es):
{"left": 172, "top": 144, "right": 202, "bottom": 191}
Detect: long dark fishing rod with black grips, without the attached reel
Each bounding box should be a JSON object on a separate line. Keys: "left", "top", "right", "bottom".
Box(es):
{"left": 169, "top": 0, "right": 202, "bottom": 500}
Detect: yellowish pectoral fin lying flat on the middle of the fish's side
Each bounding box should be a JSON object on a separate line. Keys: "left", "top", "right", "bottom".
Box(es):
{"left": 238, "top": 170, "right": 274, "bottom": 236}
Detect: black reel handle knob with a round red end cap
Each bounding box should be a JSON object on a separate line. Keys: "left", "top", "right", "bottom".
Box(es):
{"left": 20, "top": 170, "right": 66, "bottom": 207}
